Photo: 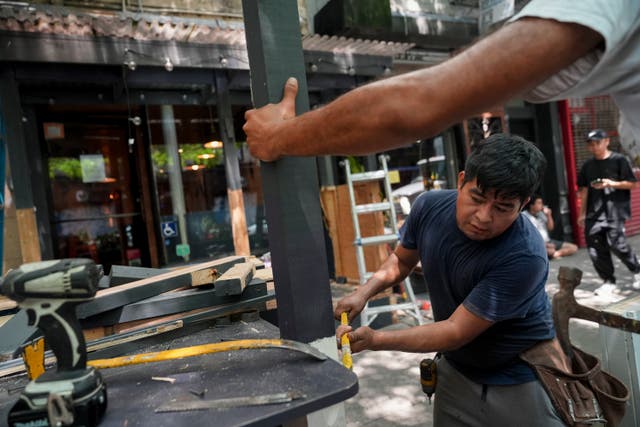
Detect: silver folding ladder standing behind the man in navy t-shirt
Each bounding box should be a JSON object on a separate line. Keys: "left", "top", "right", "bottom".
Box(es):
{"left": 342, "top": 154, "right": 424, "bottom": 326}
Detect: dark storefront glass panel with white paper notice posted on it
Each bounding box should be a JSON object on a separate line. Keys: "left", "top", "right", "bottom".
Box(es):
{"left": 41, "top": 107, "right": 148, "bottom": 272}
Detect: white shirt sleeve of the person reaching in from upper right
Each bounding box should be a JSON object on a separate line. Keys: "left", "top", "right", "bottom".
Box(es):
{"left": 511, "top": 0, "right": 640, "bottom": 159}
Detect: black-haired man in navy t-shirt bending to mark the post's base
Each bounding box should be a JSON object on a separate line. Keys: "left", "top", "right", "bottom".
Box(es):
{"left": 334, "top": 134, "right": 563, "bottom": 427}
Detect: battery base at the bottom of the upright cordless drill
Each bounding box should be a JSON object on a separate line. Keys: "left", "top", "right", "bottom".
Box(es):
{"left": 8, "top": 367, "right": 107, "bottom": 427}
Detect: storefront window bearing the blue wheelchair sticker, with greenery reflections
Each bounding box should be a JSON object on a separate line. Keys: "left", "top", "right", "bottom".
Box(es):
{"left": 148, "top": 105, "right": 266, "bottom": 264}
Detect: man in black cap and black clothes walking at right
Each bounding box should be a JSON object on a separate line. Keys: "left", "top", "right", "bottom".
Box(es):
{"left": 578, "top": 129, "right": 640, "bottom": 295}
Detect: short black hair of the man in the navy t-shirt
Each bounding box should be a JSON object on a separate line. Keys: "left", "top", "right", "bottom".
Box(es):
{"left": 462, "top": 133, "right": 547, "bottom": 202}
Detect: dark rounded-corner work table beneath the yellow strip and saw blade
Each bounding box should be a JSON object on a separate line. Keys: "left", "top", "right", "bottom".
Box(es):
{"left": 0, "top": 319, "right": 358, "bottom": 427}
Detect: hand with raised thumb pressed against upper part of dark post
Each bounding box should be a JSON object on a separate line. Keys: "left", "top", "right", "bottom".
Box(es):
{"left": 242, "top": 77, "right": 298, "bottom": 162}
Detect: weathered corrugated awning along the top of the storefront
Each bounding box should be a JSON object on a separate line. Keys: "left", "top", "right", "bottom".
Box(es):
{"left": 0, "top": 6, "right": 413, "bottom": 76}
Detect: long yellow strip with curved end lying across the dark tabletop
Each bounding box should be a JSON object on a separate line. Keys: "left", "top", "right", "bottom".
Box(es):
{"left": 87, "top": 339, "right": 326, "bottom": 369}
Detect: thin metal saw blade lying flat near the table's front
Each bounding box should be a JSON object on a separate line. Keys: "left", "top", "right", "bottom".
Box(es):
{"left": 155, "top": 391, "right": 305, "bottom": 412}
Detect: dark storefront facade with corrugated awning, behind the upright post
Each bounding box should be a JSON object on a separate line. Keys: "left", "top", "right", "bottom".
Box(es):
{"left": 0, "top": 1, "right": 410, "bottom": 271}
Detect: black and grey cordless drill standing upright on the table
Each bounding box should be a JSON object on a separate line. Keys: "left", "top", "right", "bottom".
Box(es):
{"left": 2, "top": 258, "right": 107, "bottom": 427}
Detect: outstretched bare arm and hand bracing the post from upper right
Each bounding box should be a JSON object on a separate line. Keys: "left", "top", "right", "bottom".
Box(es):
{"left": 244, "top": 18, "right": 602, "bottom": 161}
